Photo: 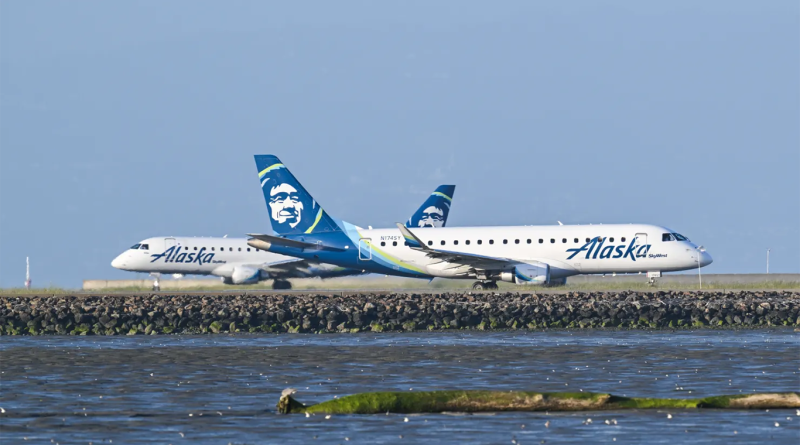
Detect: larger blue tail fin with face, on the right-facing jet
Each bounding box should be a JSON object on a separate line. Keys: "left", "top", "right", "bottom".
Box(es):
{"left": 255, "top": 155, "right": 341, "bottom": 235}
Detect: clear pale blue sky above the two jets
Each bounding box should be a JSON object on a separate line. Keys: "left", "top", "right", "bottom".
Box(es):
{"left": 0, "top": 0, "right": 800, "bottom": 287}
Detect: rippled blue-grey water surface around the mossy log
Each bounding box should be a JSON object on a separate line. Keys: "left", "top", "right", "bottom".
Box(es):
{"left": 0, "top": 330, "right": 800, "bottom": 444}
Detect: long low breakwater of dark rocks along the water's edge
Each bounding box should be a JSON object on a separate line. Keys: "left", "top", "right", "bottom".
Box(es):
{"left": 0, "top": 291, "right": 800, "bottom": 335}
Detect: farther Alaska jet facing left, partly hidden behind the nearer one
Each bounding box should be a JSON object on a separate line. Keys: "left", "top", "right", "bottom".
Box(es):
{"left": 111, "top": 185, "right": 456, "bottom": 289}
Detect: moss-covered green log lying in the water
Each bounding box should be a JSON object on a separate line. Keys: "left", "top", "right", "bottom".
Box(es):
{"left": 278, "top": 391, "right": 800, "bottom": 414}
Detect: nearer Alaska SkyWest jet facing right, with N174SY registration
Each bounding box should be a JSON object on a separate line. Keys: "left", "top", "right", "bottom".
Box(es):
{"left": 248, "top": 155, "right": 712, "bottom": 290}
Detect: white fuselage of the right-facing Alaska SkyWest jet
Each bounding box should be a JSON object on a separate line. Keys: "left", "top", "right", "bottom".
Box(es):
{"left": 359, "top": 224, "right": 712, "bottom": 278}
